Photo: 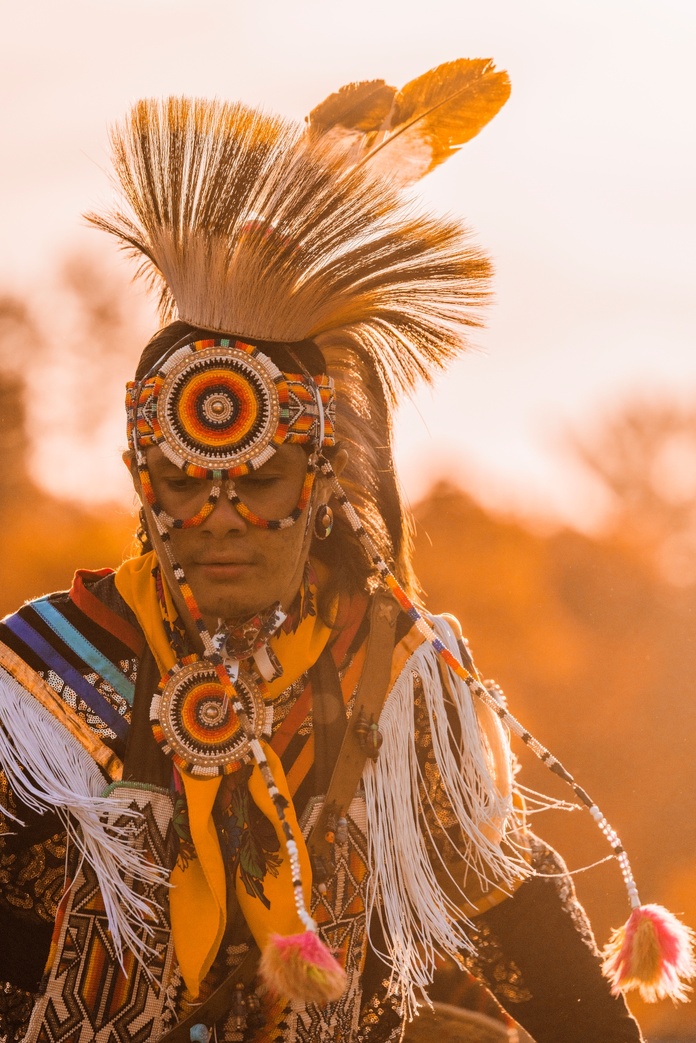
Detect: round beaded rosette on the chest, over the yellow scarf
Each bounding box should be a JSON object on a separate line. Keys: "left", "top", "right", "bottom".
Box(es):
{"left": 151, "top": 660, "right": 265, "bottom": 776}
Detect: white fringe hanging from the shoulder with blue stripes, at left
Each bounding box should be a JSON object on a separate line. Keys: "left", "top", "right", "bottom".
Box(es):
{"left": 0, "top": 669, "right": 168, "bottom": 961}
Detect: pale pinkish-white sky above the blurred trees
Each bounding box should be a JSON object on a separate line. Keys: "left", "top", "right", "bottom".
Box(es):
{"left": 0, "top": 0, "right": 696, "bottom": 524}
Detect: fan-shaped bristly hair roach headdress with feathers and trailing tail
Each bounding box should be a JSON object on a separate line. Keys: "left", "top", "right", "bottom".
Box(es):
{"left": 90, "top": 60, "right": 509, "bottom": 587}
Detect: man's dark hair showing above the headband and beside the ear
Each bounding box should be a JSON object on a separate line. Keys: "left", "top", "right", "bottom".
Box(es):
{"left": 136, "top": 319, "right": 373, "bottom": 618}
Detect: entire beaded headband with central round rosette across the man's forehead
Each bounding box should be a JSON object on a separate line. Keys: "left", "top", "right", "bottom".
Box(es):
{"left": 126, "top": 337, "right": 335, "bottom": 479}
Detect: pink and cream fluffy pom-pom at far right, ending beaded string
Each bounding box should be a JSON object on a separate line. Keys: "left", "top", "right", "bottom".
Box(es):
{"left": 602, "top": 905, "right": 696, "bottom": 1003}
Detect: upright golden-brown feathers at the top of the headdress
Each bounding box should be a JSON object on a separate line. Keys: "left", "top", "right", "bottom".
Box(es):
{"left": 308, "top": 58, "right": 510, "bottom": 184}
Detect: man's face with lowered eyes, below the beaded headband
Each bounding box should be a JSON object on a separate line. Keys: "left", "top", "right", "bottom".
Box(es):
{"left": 146, "top": 444, "right": 319, "bottom": 632}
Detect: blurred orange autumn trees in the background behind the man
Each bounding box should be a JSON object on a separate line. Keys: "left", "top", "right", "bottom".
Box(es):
{"left": 0, "top": 257, "right": 696, "bottom": 1040}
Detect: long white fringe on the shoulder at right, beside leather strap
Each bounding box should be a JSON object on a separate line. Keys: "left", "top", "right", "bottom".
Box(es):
{"left": 363, "top": 618, "right": 529, "bottom": 1019}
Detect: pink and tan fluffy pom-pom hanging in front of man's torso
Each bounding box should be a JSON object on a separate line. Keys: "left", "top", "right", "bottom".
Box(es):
{"left": 259, "top": 930, "right": 345, "bottom": 1003}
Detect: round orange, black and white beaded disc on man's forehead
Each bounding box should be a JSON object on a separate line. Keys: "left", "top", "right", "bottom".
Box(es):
{"left": 158, "top": 346, "right": 280, "bottom": 470}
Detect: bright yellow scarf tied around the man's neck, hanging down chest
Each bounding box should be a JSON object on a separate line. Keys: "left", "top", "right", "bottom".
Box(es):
{"left": 116, "top": 552, "right": 333, "bottom": 997}
